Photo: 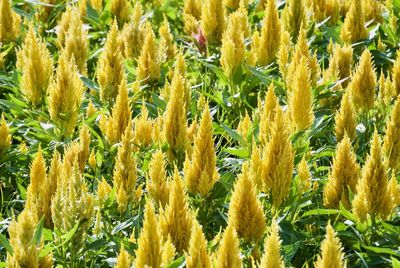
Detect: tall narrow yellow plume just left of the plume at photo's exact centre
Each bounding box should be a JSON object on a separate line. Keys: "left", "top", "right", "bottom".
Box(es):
{"left": 163, "top": 72, "right": 187, "bottom": 160}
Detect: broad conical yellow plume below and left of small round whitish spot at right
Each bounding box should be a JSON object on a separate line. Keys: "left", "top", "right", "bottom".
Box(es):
{"left": 324, "top": 134, "right": 360, "bottom": 208}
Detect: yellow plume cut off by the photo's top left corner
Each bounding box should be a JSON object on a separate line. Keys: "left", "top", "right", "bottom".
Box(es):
{"left": 0, "top": 0, "right": 21, "bottom": 43}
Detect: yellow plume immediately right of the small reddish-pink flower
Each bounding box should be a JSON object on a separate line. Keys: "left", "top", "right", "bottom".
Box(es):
{"left": 220, "top": 11, "right": 246, "bottom": 78}
